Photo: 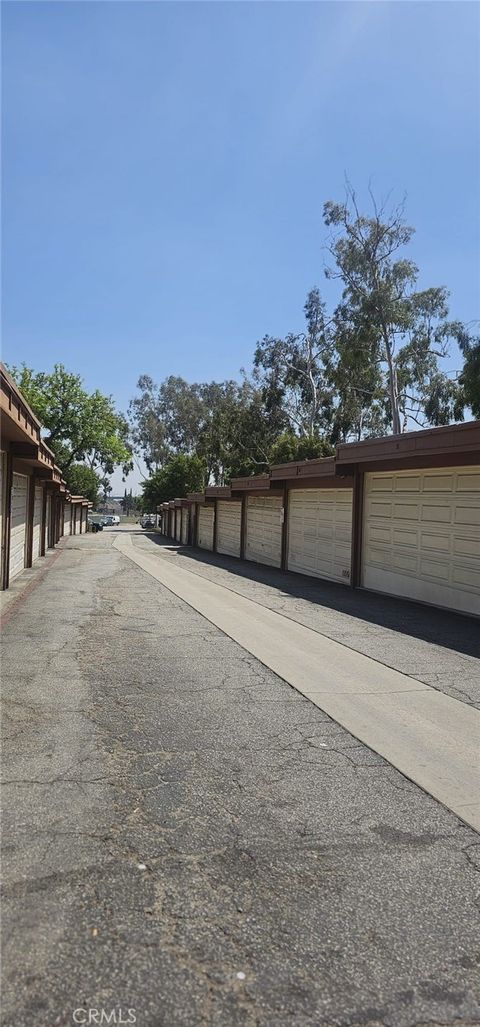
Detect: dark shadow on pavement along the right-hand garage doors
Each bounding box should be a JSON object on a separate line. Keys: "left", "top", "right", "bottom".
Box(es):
{"left": 139, "top": 528, "right": 480, "bottom": 656}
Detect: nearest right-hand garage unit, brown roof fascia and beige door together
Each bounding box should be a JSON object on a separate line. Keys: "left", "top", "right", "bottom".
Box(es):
{"left": 336, "top": 421, "right": 480, "bottom": 615}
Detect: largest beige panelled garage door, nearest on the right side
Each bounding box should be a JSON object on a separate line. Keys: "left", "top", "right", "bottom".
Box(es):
{"left": 362, "top": 467, "right": 480, "bottom": 614}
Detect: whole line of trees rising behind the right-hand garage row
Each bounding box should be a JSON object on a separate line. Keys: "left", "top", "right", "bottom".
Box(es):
{"left": 130, "top": 187, "right": 472, "bottom": 476}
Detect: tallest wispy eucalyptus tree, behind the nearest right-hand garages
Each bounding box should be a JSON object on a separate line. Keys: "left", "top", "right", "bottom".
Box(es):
{"left": 324, "top": 187, "right": 463, "bottom": 435}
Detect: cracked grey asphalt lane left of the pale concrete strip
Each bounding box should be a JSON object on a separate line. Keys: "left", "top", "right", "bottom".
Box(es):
{"left": 2, "top": 531, "right": 480, "bottom": 1027}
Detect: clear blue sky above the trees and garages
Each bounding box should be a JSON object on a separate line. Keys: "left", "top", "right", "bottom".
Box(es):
{"left": 2, "top": 0, "right": 480, "bottom": 488}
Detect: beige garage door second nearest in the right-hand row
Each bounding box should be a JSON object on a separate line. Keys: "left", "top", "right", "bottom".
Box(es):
{"left": 288, "top": 489, "right": 352, "bottom": 583}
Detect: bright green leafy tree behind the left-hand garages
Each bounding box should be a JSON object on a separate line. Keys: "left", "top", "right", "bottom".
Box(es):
{"left": 9, "top": 364, "right": 133, "bottom": 474}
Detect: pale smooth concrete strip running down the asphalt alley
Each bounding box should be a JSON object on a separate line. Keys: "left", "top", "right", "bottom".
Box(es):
{"left": 114, "top": 533, "right": 480, "bottom": 830}
